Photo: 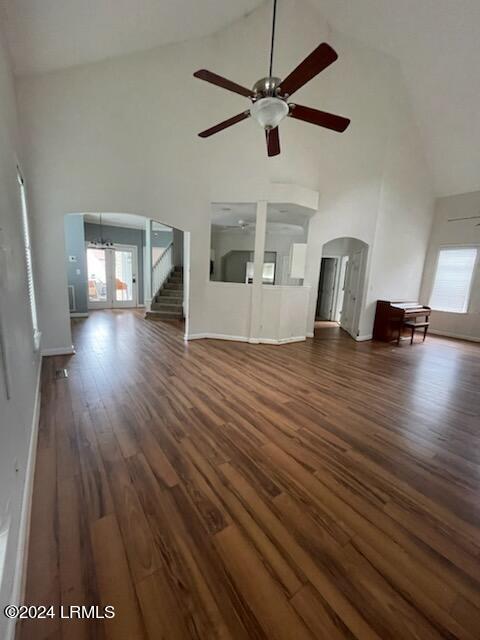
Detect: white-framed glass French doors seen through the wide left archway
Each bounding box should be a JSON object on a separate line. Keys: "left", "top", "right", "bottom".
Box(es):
{"left": 87, "top": 245, "right": 138, "bottom": 309}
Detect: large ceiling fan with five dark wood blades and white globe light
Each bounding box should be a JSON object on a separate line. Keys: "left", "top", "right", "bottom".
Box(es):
{"left": 193, "top": 0, "right": 350, "bottom": 156}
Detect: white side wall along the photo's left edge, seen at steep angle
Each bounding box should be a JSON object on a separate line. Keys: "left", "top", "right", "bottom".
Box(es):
{"left": 0, "top": 26, "right": 41, "bottom": 638}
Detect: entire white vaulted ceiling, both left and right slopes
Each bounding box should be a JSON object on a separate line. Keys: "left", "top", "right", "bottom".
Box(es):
{"left": 0, "top": 0, "right": 480, "bottom": 195}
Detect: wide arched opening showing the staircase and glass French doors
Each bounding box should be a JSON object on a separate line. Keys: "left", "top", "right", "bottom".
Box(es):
{"left": 64, "top": 212, "right": 189, "bottom": 336}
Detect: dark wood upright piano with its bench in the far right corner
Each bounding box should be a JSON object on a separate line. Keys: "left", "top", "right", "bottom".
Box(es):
{"left": 373, "top": 300, "right": 431, "bottom": 344}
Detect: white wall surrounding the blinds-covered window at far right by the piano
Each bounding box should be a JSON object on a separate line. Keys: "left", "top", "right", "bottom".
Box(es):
{"left": 421, "top": 191, "right": 480, "bottom": 340}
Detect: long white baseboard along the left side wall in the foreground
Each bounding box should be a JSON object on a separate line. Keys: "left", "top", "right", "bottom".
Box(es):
{"left": 5, "top": 360, "right": 42, "bottom": 640}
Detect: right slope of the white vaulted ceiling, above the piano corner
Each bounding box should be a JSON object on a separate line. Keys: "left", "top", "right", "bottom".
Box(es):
{"left": 310, "top": 0, "right": 480, "bottom": 195}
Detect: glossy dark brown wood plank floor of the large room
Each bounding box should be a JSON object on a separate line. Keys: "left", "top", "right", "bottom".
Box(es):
{"left": 18, "top": 311, "right": 480, "bottom": 640}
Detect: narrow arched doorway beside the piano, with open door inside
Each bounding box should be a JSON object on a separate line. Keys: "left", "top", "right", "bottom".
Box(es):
{"left": 315, "top": 238, "right": 368, "bottom": 338}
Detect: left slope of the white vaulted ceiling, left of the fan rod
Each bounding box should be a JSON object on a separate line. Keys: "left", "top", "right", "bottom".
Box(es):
{"left": 0, "top": 0, "right": 263, "bottom": 75}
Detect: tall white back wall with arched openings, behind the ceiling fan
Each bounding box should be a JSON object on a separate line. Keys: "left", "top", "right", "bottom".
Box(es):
{"left": 18, "top": 0, "right": 431, "bottom": 349}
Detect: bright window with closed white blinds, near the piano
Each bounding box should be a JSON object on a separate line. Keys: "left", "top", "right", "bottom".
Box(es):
{"left": 430, "top": 247, "right": 477, "bottom": 313}
